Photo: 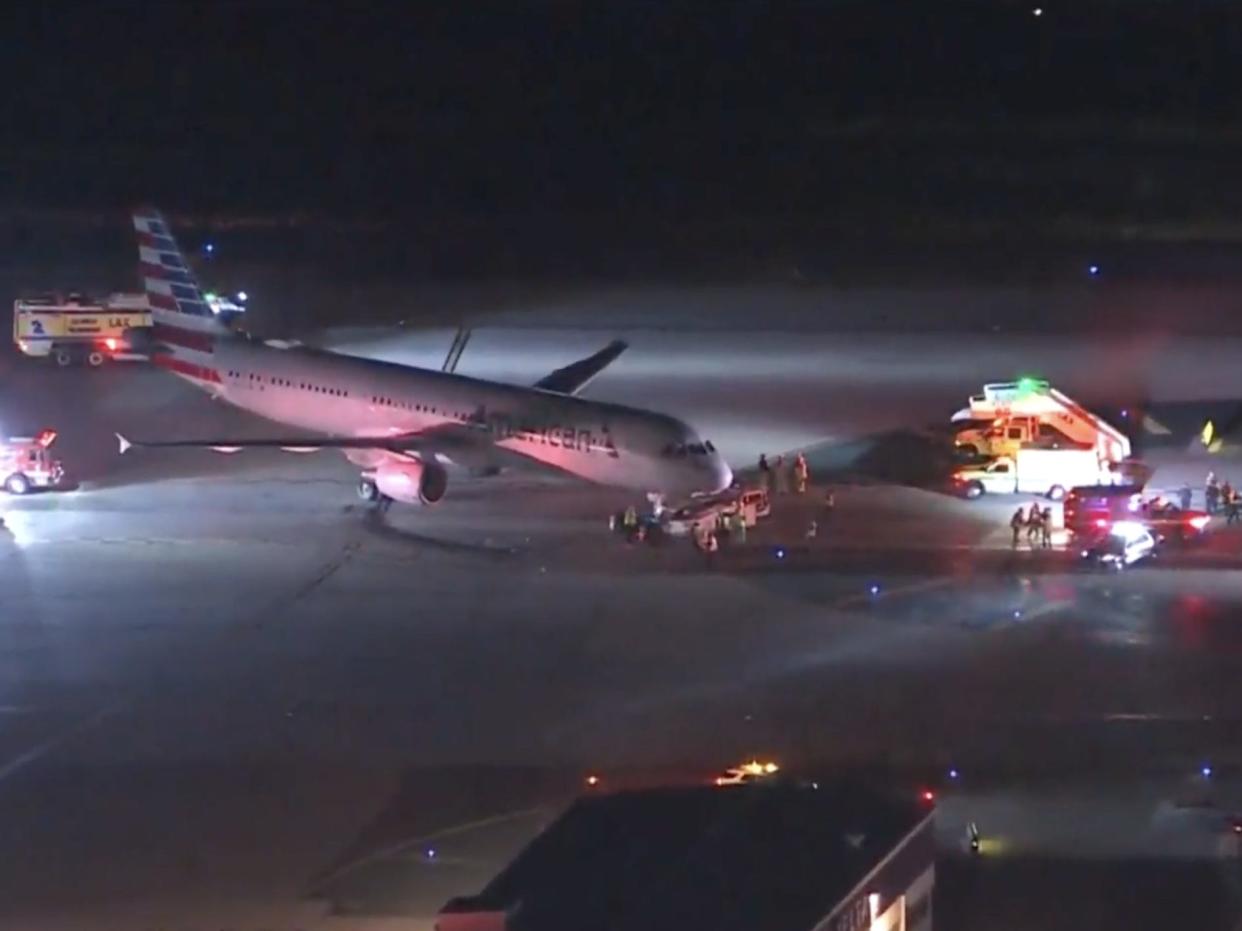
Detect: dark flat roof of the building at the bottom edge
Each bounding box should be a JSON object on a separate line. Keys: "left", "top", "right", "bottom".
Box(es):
{"left": 445, "top": 783, "right": 928, "bottom": 931}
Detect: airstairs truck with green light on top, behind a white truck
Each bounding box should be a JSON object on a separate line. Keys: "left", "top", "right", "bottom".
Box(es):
{"left": 953, "top": 379, "right": 1130, "bottom": 466}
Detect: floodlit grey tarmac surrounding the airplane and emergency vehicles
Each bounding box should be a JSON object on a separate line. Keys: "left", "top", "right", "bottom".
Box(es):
{"left": 0, "top": 310, "right": 1242, "bottom": 931}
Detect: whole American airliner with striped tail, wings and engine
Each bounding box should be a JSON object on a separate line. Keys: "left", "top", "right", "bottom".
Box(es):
{"left": 118, "top": 210, "right": 733, "bottom": 504}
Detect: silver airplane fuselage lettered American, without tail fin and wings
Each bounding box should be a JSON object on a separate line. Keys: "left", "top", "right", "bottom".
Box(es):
{"left": 209, "top": 339, "right": 732, "bottom": 495}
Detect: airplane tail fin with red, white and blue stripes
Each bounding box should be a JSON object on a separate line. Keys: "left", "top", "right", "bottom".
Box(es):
{"left": 134, "top": 209, "right": 229, "bottom": 387}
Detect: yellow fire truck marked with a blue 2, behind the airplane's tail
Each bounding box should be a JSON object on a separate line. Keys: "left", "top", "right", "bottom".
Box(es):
{"left": 12, "top": 293, "right": 152, "bottom": 367}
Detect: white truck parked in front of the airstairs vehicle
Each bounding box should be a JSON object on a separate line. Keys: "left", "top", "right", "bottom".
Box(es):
{"left": 953, "top": 449, "right": 1123, "bottom": 501}
